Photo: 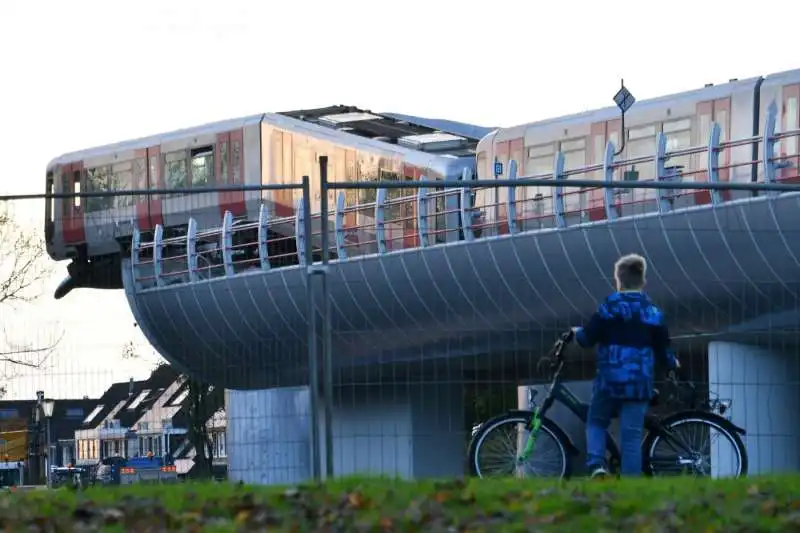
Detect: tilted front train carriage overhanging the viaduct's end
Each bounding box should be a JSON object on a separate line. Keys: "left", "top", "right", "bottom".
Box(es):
{"left": 45, "top": 105, "right": 479, "bottom": 299}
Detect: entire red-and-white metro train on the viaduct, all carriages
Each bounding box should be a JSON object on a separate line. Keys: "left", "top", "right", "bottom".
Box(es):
{"left": 45, "top": 69, "right": 800, "bottom": 298}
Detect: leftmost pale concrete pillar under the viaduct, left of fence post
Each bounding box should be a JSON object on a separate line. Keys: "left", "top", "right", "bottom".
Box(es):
{"left": 225, "top": 387, "right": 311, "bottom": 485}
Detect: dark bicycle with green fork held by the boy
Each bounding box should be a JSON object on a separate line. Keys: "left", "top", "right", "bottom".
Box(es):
{"left": 469, "top": 331, "right": 748, "bottom": 478}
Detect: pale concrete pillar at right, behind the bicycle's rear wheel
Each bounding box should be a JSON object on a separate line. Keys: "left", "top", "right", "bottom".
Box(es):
{"left": 708, "top": 342, "right": 800, "bottom": 476}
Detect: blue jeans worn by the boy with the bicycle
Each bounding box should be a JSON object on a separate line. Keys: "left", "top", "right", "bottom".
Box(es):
{"left": 586, "top": 391, "right": 650, "bottom": 476}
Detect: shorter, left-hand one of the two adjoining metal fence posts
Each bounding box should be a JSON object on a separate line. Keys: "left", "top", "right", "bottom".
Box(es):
{"left": 295, "top": 176, "right": 322, "bottom": 481}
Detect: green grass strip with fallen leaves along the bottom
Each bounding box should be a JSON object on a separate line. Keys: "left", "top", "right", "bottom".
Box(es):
{"left": 0, "top": 476, "right": 800, "bottom": 533}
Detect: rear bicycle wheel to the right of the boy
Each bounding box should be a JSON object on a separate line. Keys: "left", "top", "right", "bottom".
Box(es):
{"left": 642, "top": 411, "right": 748, "bottom": 478}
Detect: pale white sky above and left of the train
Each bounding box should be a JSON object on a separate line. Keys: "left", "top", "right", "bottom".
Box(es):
{"left": 0, "top": 0, "right": 800, "bottom": 398}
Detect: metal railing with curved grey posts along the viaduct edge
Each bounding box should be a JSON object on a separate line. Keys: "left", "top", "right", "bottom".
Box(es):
{"left": 131, "top": 103, "right": 800, "bottom": 290}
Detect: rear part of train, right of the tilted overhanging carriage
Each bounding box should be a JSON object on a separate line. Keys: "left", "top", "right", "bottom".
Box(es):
{"left": 476, "top": 70, "right": 800, "bottom": 234}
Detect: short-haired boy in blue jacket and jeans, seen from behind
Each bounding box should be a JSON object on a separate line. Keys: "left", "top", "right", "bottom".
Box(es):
{"left": 573, "top": 254, "right": 680, "bottom": 478}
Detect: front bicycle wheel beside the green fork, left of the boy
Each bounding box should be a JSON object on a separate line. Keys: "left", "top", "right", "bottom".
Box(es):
{"left": 469, "top": 413, "right": 570, "bottom": 478}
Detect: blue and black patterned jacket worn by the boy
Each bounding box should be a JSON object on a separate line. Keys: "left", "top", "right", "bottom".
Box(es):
{"left": 575, "top": 292, "right": 676, "bottom": 400}
